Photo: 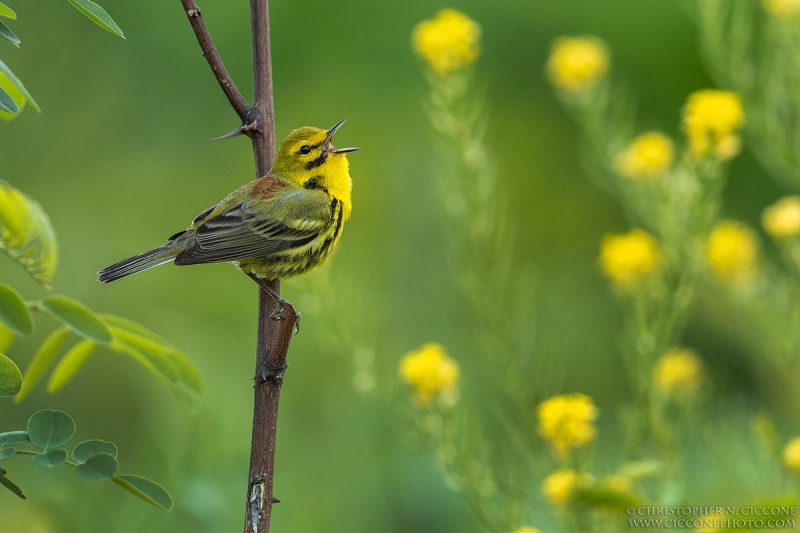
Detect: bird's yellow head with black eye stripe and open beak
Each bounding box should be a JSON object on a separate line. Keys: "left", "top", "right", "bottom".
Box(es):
{"left": 270, "top": 120, "right": 358, "bottom": 188}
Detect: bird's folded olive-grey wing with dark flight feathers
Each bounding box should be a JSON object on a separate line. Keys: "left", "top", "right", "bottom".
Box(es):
{"left": 175, "top": 183, "right": 332, "bottom": 265}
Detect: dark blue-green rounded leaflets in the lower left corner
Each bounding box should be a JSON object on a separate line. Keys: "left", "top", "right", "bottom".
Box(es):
{"left": 0, "top": 409, "right": 172, "bottom": 511}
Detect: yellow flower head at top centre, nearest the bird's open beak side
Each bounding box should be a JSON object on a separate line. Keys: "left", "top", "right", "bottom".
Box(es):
{"left": 411, "top": 9, "right": 481, "bottom": 76}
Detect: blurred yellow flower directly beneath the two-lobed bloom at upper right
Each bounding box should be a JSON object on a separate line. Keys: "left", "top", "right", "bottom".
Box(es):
{"left": 707, "top": 220, "right": 758, "bottom": 283}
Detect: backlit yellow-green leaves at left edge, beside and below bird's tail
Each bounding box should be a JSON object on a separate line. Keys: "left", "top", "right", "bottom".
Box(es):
{"left": 0, "top": 182, "right": 203, "bottom": 411}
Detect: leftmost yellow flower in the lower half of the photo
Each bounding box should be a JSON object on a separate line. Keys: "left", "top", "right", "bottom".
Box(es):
{"left": 400, "top": 343, "right": 459, "bottom": 406}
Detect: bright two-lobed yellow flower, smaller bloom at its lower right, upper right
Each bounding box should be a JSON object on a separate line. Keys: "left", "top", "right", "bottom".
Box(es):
{"left": 683, "top": 89, "right": 744, "bottom": 160}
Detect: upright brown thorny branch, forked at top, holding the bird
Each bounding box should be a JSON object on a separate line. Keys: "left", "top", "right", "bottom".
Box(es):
{"left": 181, "top": 0, "right": 298, "bottom": 533}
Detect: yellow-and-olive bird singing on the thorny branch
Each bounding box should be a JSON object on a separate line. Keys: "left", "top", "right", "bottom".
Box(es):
{"left": 97, "top": 120, "right": 359, "bottom": 312}
